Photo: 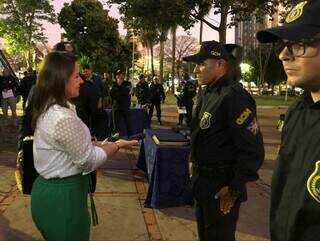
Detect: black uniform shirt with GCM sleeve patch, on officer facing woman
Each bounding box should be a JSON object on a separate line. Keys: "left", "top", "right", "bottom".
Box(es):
{"left": 191, "top": 76, "right": 264, "bottom": 196}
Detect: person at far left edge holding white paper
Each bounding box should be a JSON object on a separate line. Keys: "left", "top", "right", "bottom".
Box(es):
{"left": 0, "top": 69, "right": 19, "bottom": 125}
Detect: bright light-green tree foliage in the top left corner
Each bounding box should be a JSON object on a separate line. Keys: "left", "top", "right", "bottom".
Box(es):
{"left": 0, "top": 0, "right": 56, "bottom": 65}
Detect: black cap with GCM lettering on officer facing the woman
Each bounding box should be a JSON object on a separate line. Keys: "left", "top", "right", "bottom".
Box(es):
{"left": 183, "top": 40, "right": 229, "bottom": 63}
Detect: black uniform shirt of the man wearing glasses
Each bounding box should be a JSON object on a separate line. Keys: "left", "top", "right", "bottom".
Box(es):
{"left": 270, "top": 93, "right": 320, "bottom": 241}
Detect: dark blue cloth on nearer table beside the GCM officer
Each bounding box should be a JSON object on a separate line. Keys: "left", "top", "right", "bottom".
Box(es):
{"left": 137, "top": 129, "right": 192, "bottom": 208}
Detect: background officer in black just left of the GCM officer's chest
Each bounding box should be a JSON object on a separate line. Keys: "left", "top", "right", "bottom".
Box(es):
{"left": 178, "top": 75, "right": 197, "bottom": 127}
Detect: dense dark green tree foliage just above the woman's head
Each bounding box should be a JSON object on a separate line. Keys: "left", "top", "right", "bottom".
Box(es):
{"left": 58, "top": 0, "right": 132, "bottom": 73}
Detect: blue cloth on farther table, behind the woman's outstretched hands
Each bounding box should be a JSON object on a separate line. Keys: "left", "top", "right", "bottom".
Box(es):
{"left": 106, "top": 108, "right": 150, "bottom": 136}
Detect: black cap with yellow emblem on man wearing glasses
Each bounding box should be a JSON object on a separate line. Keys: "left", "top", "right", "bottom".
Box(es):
{"left": 257, "top": 0, "right": 320, "bottom": 43}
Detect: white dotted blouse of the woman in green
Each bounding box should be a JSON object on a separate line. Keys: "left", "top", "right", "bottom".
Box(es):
{"left": 33, "top": 103, "right": 107, "bottom": 179}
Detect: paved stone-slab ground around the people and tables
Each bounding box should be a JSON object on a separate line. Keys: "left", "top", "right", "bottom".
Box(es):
{"left": 0, "top": 107, "right": 285, "bottom": 241}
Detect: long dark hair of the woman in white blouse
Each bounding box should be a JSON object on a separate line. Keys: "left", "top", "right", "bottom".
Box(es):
{"left": 32, "top": 51, "right": 76, "bottom": 129}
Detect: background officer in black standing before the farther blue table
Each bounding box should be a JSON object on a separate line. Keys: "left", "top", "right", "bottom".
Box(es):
{"left": 110, "top": 70, "right": 133, "bottom": 136}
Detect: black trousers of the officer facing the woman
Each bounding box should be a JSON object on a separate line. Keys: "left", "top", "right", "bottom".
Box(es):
{"left": 191, "top": 169, "right": 241, "bottom": 241}
